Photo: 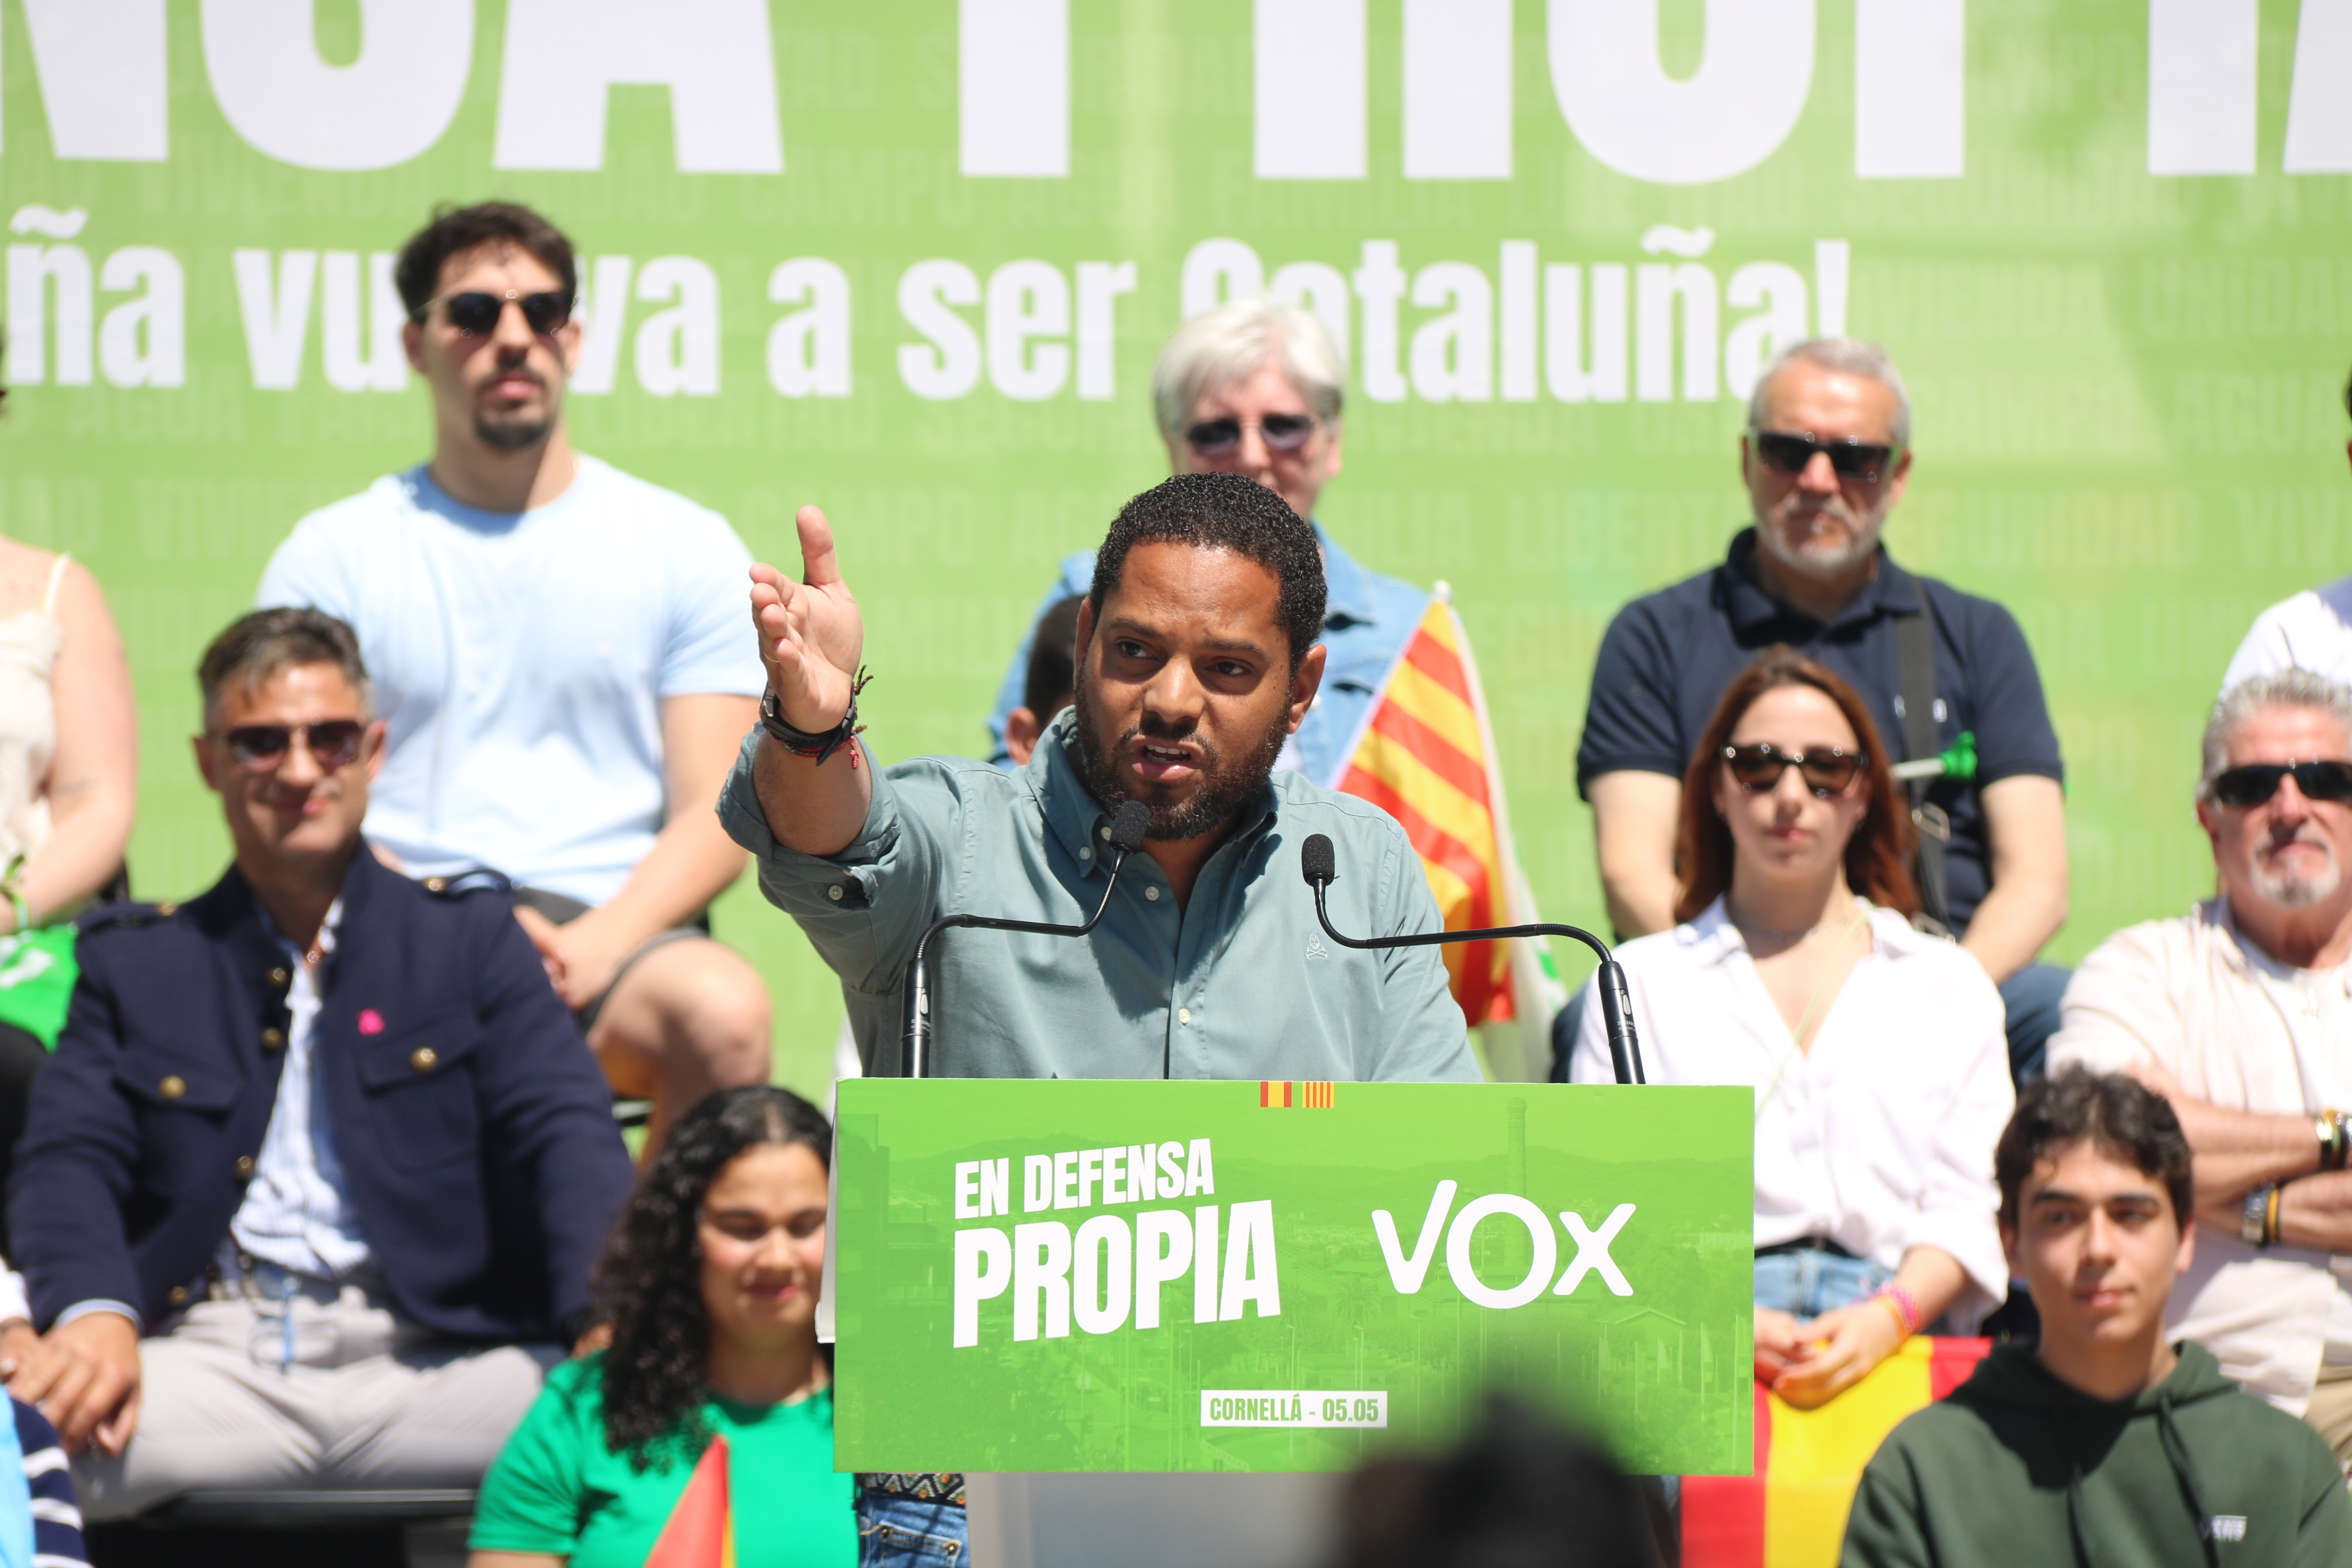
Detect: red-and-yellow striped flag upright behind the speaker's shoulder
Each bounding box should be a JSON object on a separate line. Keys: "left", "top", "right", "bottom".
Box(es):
{"left": 1338, "top": 583, "right": 1564, "bottom": 1077}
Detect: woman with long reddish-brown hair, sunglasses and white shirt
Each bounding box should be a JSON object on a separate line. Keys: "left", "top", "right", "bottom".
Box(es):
{"left": 1571, "top": 646, "right": 2013, "bottom": 1406}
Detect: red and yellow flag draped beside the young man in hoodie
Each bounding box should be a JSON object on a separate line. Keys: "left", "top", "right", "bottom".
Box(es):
{"left": 1681, "top": 1338, "right": 1992, "bottom": 1568}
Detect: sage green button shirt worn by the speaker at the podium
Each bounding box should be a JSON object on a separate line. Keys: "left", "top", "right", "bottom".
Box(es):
{"left": 720, "top": 712, "right": 1479, "bottom": 1084}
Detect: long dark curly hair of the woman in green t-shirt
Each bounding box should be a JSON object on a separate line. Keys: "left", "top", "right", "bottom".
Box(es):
{"left": 597, "top": 1084, "right": 832, "bottom": 1472}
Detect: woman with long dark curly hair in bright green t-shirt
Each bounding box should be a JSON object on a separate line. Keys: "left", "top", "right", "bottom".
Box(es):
{"left": 470, "top": 1084, "right": 861, "bottom": 1568}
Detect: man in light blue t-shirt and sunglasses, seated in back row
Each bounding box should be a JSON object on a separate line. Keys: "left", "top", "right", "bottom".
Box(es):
{"left": 259, "top": 202, "right": 769, "bottom": 1147}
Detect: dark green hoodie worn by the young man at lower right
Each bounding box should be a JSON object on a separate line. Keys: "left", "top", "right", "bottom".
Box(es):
{"left": 1842, "top": 1342, "right": 2352, "bottom": 1568}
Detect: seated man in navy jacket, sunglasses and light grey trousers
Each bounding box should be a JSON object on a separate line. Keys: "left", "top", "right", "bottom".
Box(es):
{"left": 9, "top": 609, "right": 630, "bottom": 1518}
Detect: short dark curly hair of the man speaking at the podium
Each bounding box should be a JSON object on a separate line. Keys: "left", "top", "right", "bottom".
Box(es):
{"left": 1087, "top": 472, "right": 1324, "bottom": 674}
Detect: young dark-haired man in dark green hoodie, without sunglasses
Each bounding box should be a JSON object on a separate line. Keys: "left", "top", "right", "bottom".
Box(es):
{"left": 1842, "top": 1068, "right": 2352, "bottom": 1568}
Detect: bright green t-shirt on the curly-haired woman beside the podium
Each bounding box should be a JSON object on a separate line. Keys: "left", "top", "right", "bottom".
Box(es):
{"left": 470, "top": 1352, "right": 858, "bottom": 1568}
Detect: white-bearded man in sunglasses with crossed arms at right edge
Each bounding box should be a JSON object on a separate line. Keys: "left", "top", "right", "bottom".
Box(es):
{"left": 2051, "top": 670, "right": 2352, "bottom": 1460}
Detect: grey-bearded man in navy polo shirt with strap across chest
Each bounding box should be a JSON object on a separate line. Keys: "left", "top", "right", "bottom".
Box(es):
{"left": 1569, "top": 339, "right": 2067, "bottom": 1084}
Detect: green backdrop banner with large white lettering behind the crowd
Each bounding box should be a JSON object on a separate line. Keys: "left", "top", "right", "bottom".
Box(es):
{"left": 0, "top": 0, "right": 2352, "bottom": 1088}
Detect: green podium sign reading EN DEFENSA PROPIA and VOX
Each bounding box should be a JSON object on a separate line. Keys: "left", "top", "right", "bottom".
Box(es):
{"left": 832, "top": 1079, "right": 1755, "bottom": 1474}
